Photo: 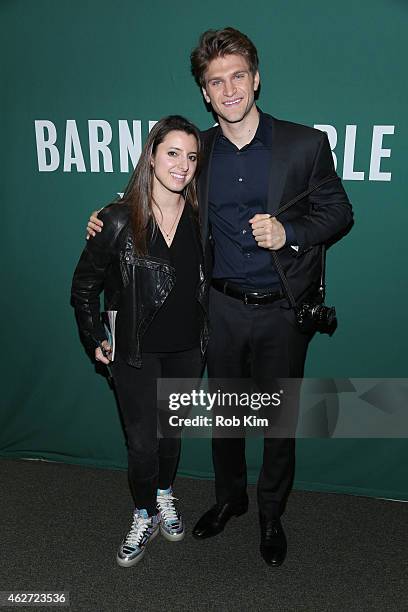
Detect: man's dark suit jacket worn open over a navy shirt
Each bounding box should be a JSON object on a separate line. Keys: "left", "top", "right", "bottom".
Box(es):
{"left": 198, "top": 115, "right": 353, "bottom": 300}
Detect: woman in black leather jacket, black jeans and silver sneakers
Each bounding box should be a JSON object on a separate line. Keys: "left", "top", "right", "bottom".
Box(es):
{"left": 72, "top": 116, "right": 207, "bottom": 567}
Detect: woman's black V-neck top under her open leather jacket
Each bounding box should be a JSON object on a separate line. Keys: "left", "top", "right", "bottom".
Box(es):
{"left": 142, "top": 204, "right": 202, "bottom": 353}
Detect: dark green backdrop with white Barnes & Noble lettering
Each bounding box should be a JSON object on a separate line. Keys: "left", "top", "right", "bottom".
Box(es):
{"left": 0, "top": 0, "right": 408, "bottom": 499}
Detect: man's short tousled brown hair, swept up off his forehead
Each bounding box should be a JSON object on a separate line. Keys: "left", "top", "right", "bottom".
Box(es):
{"left": 190, "top": 28, "right": 259, "bottom": 87}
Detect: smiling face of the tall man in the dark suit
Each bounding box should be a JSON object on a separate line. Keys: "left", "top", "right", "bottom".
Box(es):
{"left": 202, "top": 54, "right": 259, "bottom": 123}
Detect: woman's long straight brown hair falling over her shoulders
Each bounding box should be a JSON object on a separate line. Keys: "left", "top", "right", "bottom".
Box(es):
{"left": 122, "top": 115, "right": 200, "bottom": 256}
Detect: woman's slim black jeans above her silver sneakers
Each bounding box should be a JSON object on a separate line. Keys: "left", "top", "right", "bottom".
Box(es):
{"left": 112, "top": 348, "right": 202, "bottom": 516}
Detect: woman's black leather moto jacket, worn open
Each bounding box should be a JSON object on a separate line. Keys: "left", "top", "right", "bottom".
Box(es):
{"left": 71, "top": 202, "right": 208, "bottom": 367}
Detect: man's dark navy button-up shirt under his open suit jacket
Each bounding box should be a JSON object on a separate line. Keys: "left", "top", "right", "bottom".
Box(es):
{"left": 209, "top": 111, "right": 296, "bottom": 290}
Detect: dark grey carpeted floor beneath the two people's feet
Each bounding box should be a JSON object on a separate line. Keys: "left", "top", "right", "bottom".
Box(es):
{"left": 0, "top": 459, "right": 408, "bottom": 612}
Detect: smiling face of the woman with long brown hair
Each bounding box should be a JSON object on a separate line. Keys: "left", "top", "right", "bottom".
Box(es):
{"left": 151, "top": 130, "right": 198, "bottom": 193}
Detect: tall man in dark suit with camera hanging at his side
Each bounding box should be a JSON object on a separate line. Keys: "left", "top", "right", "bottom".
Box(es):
{"left": 87, "top": 28, "right": 352, "bottom": 566}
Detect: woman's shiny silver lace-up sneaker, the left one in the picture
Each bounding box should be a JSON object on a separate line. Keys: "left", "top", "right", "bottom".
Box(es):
{"left": 116, "top": 508, "right": 160, "bottom": 567}
